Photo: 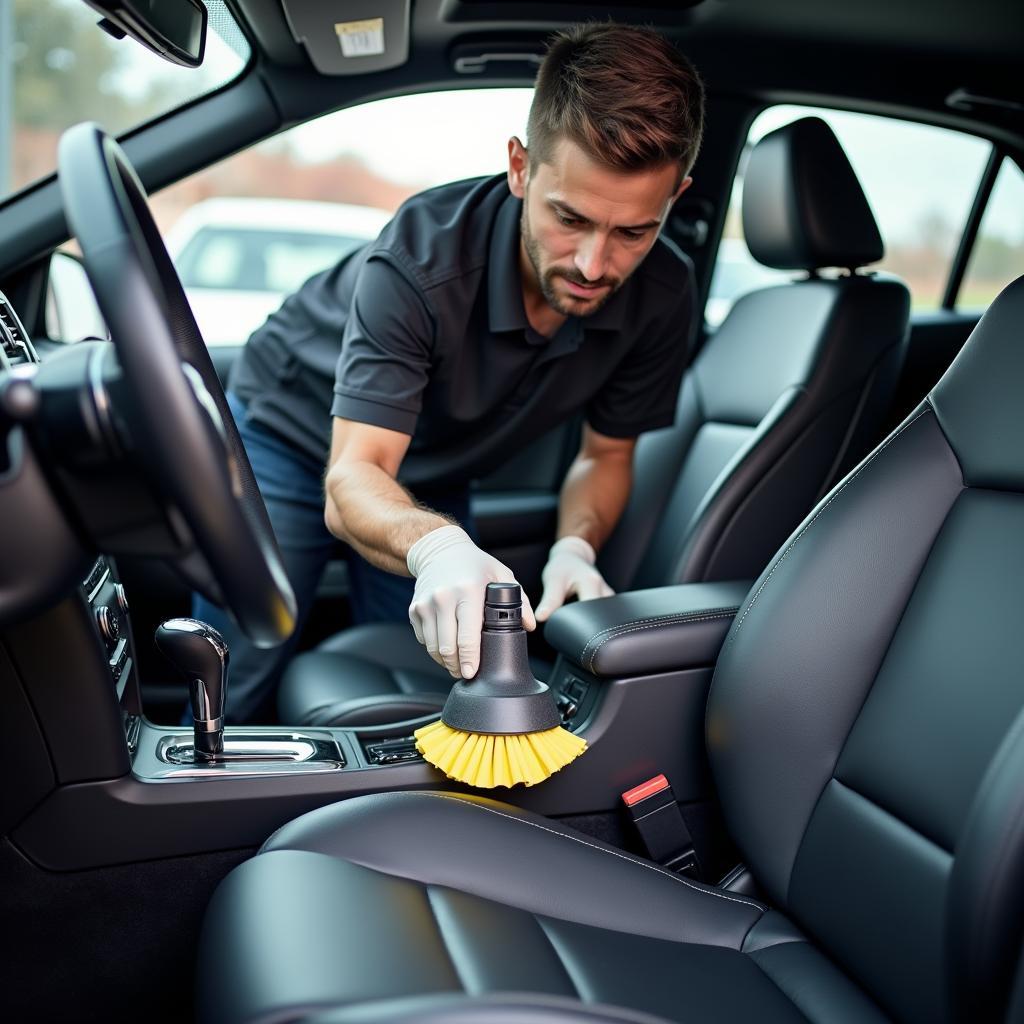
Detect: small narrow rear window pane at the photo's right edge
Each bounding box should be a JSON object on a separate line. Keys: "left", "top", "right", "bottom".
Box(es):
{"left": 956, "top": 158, "right": 1024, "bottom": 312}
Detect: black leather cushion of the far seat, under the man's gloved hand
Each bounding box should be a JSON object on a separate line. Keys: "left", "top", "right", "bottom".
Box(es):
{"left": 278, "top": 623, "right": 551, "bottom": 726}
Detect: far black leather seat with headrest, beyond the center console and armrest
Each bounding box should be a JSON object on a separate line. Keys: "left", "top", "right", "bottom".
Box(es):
{"left": 279, "top": 118, "right": 909, "bottom": 725}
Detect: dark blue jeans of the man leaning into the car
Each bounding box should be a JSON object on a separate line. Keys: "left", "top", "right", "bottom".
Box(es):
{"left": 192, "top": 391, "right": 473, "bottom": 724}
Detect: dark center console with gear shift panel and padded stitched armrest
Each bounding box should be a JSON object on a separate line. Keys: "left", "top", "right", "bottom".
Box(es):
{"left": 6, "top": 560, "right": 749, "bottom": 870}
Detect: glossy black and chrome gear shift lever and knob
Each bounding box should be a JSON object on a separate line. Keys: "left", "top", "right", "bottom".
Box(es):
{"left": 154, "top": 618, "right": 227, "bottom": 761}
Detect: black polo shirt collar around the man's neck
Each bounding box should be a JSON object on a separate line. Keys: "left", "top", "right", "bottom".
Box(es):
{"left": 487, "top": 193, "right": 639, "bottom": 334}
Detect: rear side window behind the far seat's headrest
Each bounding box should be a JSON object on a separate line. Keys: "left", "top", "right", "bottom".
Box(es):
{"left": 706, "top": 105, "right": 991, "bottom": 326}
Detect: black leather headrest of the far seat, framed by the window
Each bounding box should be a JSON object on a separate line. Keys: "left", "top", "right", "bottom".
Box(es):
{"left": 743, "top": 118, "right": 885, "bottom": 270}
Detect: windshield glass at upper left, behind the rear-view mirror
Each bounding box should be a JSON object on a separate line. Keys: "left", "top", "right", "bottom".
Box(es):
{"left": 0, "top": 0, "right": 249, "bottom": 199}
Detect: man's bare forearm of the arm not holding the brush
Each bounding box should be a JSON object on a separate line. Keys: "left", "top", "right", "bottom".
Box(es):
{"left": 558, "top": 453, "right": 633, "bottom": 551}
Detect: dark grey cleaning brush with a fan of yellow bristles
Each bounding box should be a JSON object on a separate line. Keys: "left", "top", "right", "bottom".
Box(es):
{"left": 415, "top": 583, "right": 587, "bottom": 788}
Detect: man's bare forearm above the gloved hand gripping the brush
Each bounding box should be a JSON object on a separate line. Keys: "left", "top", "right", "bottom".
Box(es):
{"left": 324, "top": 462, "right": 451, "bottom": 575}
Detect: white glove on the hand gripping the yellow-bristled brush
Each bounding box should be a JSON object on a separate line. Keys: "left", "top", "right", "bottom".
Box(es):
{"left": 406, "top": 526, "right": 537, "bottom": 679}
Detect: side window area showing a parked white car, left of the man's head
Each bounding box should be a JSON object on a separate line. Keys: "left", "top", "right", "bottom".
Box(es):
{"left": 152, "top": 88, "right": 532, "bottom": 345}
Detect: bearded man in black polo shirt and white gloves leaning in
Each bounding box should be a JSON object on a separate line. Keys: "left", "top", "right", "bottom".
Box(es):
{"left": 207, "top": 24, "right": 702, "bottom": 721}
